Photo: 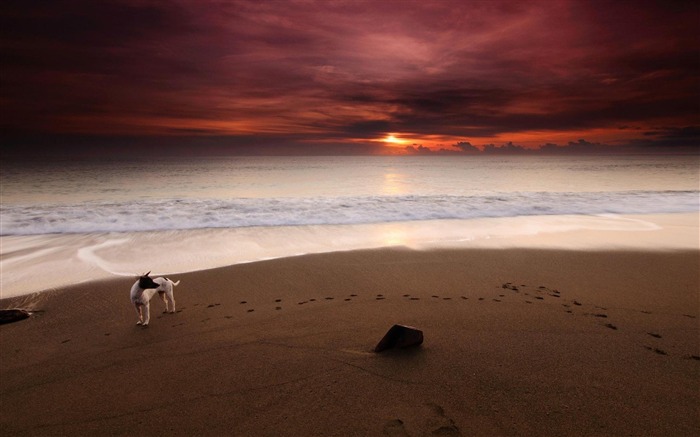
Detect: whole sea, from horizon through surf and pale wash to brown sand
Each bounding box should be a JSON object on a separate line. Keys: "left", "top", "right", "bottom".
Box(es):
{"left": 0, "top": 156, "right": 700, "bottom": 297}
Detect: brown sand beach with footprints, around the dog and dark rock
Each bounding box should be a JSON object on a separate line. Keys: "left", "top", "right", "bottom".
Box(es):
{"left": 0, "top": 249, "right": 700, "bottom": 436}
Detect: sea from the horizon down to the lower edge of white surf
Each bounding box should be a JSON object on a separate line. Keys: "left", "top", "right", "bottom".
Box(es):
{"left": 0, "top": 156, "right": 700, "bottom": 236}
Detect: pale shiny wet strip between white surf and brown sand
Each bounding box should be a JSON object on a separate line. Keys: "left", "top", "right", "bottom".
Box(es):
{"left": 0, "top": 212, "right": 700, "bottom": 298}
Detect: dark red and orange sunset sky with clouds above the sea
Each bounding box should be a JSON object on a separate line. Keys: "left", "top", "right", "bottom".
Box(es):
{"left": 0, "top": 0, "right": 700, "bottom": 154}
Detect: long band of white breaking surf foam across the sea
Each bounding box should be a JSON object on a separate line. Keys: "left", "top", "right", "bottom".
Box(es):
{"left": 0, "top": 191, "right": 700, "bottom": 235}
